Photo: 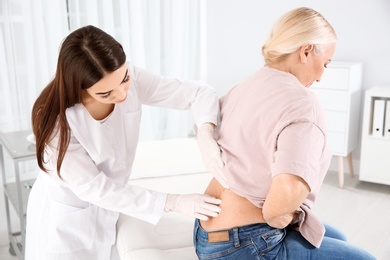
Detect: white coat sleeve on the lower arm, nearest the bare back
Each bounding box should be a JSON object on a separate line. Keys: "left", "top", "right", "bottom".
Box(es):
{"left": 46, "top": 133, "right": 166, "bottom": 224}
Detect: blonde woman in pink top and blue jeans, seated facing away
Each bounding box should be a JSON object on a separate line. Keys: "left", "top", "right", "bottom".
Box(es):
{"left": 194, "top": 7, "right": 374, "bottom": 260}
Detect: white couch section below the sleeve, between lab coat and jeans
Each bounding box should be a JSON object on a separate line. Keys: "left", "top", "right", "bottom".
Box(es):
{"left": 117, "top": 213, "right": 197, "bottom": 260}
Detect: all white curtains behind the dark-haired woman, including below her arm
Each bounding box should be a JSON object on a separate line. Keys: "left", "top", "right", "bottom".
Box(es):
{"left": 0, "top": 0, "right": 203, "bottom": 139}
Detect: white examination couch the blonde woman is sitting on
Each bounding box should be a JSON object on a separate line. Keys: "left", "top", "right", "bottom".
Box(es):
{"left": 117, "top": 138, "right": 212, "bottom": 260}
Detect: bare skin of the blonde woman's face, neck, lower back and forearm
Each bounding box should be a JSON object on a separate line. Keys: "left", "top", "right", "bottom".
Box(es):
{"left": 201, "top": 44, "right": 336, "bottom": 231}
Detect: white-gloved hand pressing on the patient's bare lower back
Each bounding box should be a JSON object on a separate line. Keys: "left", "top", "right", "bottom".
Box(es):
{"left": 164, "top": 194, "right": 221, "bottom": 220}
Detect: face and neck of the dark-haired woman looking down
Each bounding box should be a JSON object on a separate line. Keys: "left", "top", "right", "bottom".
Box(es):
{"left": 82, "top": 64, "right": 130, "bottom": 120}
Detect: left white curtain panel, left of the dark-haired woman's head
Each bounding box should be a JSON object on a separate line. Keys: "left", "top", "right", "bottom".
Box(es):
{"left": 0, "top": 0, "right": 68, "bottom": 132}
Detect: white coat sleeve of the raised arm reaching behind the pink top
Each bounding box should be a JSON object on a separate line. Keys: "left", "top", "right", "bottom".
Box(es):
{"left": 132, "top": 64, "right": 219, "bottom": 126}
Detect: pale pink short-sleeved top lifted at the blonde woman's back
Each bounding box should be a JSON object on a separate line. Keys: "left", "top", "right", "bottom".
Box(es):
{"left": 218, "top": 67, "right": 331, "bottom": 247}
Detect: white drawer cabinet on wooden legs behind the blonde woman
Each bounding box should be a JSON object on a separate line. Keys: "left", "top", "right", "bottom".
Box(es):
{"left": 310, "top": 61, "right": 363, "bottom": 187}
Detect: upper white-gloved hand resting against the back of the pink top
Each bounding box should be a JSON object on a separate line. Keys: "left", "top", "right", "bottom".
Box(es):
{"left": 196, "top": 123, "right": 229, "bottom": 188}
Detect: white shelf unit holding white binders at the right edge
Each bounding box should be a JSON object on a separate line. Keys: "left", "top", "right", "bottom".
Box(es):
{"left": 359, "top": 86, "right": 390, "bottom": 185}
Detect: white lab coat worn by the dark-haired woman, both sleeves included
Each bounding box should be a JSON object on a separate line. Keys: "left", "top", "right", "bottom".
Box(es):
{"left": 25, "top": 66, "right": 219, "bottom": 260}
